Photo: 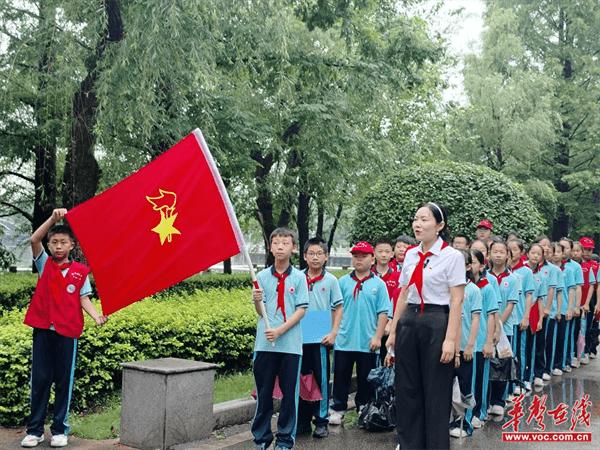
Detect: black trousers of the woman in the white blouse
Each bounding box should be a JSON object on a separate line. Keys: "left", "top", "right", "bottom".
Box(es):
{"left": 395, "top": 305, "right": 454, "bottom": 450}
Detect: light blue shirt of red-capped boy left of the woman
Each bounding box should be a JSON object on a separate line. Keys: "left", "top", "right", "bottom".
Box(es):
{"left": 334, "top": 272, "right": 390, "bottom": 353}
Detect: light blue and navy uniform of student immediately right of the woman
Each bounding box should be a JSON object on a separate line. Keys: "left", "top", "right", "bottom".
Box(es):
{"left": 450, "top": 281, "right": 483, "bottom": 436}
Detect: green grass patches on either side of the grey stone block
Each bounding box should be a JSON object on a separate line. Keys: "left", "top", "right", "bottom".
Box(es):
{"left": 70, "top": 372, "right": 254, "bottom": 440}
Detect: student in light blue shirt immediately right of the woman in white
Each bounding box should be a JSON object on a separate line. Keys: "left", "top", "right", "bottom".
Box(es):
{"left": 450, "top": 250, "right": 482, "bottom": 438}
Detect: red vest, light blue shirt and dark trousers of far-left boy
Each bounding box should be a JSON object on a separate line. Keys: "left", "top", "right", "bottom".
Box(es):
{"left": 24, "top": 250, "right": 92, "bottom": 437}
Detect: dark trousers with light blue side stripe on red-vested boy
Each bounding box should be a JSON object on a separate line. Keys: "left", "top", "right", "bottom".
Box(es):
{"left": 27, "top": 328, "right": 77, "bottom": 436}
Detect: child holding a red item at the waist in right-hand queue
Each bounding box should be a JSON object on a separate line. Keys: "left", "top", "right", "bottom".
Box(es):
{"left": 526, "top": 243, "right": 556, "bottom": 387}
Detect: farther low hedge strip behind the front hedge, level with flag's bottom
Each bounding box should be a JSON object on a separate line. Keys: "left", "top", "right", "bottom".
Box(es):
{"left": 0, "top": 273, "right": 252, "bottom": 314}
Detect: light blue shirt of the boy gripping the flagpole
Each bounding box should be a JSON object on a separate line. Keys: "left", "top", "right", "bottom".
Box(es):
{"left": 254, "top": 266, "right": 308, "bottom": 355}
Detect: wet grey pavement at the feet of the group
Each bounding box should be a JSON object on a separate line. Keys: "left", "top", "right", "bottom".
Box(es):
{"left": 203, "top": 359, "right": 600, "bottom": 450}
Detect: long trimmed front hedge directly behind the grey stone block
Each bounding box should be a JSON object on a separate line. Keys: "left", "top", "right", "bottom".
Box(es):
{"left": 0, "top": 289, "right": 256, "bottom": 425}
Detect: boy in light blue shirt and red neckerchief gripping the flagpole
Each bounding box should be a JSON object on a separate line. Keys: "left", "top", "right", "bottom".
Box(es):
{"left": 251, "top": 228, "right": 309, "bottom": 449}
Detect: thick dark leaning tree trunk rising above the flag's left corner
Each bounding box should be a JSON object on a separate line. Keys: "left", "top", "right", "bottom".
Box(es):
{"left": 63, "top": 0, "right": 123, "bottom": 208}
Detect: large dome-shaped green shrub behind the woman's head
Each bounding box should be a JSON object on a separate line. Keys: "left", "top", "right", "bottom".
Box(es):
{"left": 351, "top": 161, "right": 546, "bottom": 241}
